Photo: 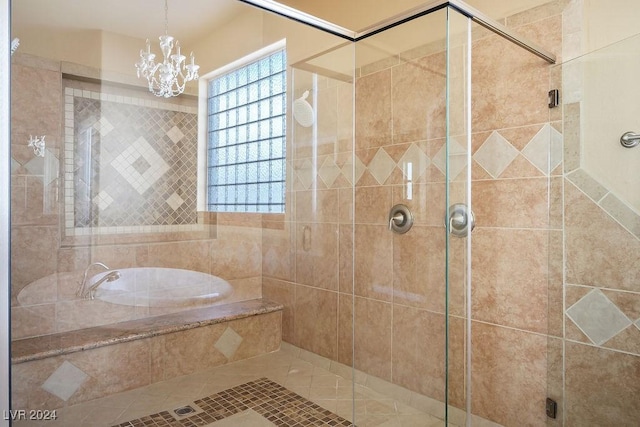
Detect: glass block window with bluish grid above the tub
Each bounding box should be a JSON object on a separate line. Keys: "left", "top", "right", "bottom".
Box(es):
{"left": 207, "top": 49, "right": 287, "bottom": 212}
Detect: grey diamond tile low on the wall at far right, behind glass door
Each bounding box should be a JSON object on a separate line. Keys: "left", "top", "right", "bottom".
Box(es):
{"left": 567, "top": 289, "right": 631, "bottom": 345}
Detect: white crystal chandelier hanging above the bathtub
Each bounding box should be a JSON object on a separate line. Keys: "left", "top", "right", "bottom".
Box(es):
{"left": 136, "top": 0, "right": 200, "bottom": 98}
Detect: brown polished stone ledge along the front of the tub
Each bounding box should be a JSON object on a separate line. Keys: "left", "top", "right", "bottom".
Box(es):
{"left": 11, "top": 299, "right": 283, "bottom": 364}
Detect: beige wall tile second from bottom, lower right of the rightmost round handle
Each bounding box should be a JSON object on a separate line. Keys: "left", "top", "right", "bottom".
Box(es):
{"left": 471, "top": 228, "right": 549, "bottom": 333}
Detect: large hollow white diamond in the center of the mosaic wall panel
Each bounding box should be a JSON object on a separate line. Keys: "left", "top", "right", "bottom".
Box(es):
{"left": 111, "top": 137, "right": 169, "bottom": 194}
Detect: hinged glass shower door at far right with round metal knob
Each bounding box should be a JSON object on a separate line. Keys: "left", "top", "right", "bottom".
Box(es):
{"left": 550, "top": 31, "right": 640, "bottom": 426}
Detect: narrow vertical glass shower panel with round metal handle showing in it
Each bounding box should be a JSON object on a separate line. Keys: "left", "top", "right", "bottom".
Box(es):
{"left": 443, "top": 8, "right": 475, "bottom": 425}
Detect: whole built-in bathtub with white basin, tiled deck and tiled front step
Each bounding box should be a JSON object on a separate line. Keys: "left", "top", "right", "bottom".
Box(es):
{"left": 11, "top": 268, "right": 283, "bottom": 410}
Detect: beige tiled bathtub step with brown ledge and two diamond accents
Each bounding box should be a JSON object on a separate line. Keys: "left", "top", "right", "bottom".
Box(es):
{"left": 12, "top": 299, "right": 282, "bottom": 409}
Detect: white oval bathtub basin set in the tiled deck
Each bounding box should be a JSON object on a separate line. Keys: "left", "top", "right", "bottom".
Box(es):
{"left": 87, "top": 267, "right": 231, "bottom": 307}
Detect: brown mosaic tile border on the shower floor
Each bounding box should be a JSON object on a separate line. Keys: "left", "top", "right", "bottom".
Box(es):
{"left": 114, "top": 378, "right": 353, "bottom": 427}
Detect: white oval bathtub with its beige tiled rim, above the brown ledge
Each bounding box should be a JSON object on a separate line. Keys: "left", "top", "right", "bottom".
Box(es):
{"left": 11, "top": 267, "right": 262, "bottom": 339}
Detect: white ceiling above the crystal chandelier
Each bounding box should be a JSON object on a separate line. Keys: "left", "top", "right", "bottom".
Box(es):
{"left": 11, "top": 0, "right": 249, "bottom": 43}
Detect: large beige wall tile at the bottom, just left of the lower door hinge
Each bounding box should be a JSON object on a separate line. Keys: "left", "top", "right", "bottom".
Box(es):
{"left": 471, "top": 322, "right": 548, "bottom": 426}
